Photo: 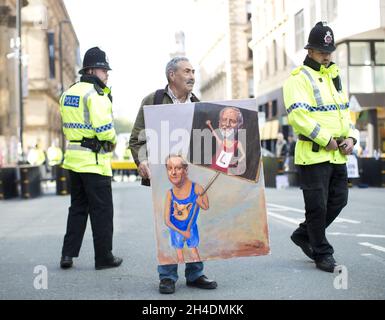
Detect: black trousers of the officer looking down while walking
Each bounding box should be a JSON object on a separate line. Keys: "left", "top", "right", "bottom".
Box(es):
{"left": 294, "top": 162, "right": 348, "bottom": 261}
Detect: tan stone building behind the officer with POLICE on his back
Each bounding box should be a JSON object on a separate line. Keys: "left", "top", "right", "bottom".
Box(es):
{"left": 0, "top": 0, "right": 80, "bottom": 163}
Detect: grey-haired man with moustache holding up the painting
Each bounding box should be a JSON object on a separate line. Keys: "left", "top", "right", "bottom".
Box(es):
{"left": 130, "top": 57, "right": 217, "bottom": 294}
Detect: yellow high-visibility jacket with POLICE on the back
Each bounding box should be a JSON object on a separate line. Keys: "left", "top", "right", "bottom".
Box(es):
{"left": 60, "top": 82, "right": 117, "bottom": 176}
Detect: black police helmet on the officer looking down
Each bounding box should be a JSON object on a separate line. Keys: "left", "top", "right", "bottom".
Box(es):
{"left": 305, "top": 21, "right": 336, "bottom": 53}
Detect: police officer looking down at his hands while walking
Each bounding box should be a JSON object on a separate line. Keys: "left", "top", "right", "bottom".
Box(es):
{"left": 283, "top": 22, "right": 357, "bottom": 272}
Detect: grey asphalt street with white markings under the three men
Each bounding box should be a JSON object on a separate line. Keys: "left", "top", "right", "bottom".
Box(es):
{"left": 0, "top": 182, "right": 385, "bottom": 300}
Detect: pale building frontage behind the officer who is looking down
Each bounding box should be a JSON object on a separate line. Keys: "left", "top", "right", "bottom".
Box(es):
{"left": 249, "top": 0, "right": 385, "bottom": 156}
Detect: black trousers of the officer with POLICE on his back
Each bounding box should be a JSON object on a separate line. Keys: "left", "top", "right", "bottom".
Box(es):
{"left": 62, "top": 171, "right": 113, "bottom": 263}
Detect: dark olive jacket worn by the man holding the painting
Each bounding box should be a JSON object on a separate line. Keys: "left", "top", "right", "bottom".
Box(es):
{"left": 129, "top": 87, "right": 199, "bottom": 186}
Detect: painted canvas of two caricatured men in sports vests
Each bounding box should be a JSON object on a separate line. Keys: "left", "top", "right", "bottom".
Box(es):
{"left": 144, "top": 100, "right": 270, "bottom": 265}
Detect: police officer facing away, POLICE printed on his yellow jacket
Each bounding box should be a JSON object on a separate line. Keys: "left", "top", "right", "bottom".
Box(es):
{"left": 60, "top": 47, "right": 123, "bottom": 270}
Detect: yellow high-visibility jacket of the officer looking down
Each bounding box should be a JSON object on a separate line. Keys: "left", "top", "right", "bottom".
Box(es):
{"left": 283, "top": 64, "right": 358, "bottom": 165}
